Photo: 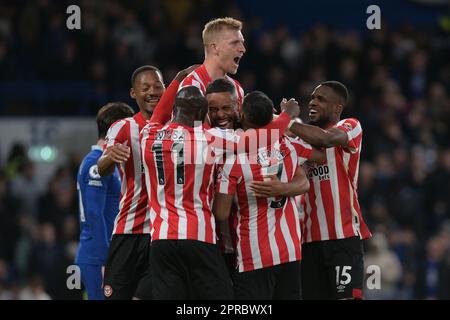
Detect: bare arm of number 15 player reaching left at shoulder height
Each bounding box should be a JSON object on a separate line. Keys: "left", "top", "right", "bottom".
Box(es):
{"left": 289, "top": 122, "right": 348, "bottom": 148}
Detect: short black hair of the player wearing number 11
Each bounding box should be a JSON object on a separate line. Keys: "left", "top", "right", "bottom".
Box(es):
{"left": 173, "top": 86, "right": 208, "bottom": 120}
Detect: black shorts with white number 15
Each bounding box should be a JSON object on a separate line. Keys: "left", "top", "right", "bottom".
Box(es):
{"left": 302, "top": 237, "right": 364, "bottom": 300}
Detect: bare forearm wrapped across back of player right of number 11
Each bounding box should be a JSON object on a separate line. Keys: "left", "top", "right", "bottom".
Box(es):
{"left": 249, "top": 167, "right": 309, "bottom": 198}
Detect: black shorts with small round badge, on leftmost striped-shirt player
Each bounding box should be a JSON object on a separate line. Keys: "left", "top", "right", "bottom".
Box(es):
{"left": 103, "top": 234, "right": 152, "bottom": 300}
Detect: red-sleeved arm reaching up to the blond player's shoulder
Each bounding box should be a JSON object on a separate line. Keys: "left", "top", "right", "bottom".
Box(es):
{"left": 149, "top": 64, "right": 200, "bottom": 124}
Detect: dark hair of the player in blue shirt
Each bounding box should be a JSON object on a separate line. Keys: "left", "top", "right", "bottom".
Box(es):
{"left": 96, "top": 102, "right": 134, "bottom": 138}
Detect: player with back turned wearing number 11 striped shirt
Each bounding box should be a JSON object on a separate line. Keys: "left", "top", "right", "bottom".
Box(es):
{"left": 141, "top": 86, "right": 233, "bottom": 300}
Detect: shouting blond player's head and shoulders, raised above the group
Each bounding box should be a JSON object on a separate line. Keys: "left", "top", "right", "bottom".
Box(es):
{"left": 180, "top": 18, "right": 245, "bottom": 112}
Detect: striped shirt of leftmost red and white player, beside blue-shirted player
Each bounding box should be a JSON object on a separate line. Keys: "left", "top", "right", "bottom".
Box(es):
{"left": 105, "top": 112, "right": 150, "bottom": 234}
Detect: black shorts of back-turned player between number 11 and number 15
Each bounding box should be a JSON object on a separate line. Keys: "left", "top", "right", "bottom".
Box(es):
{"left": 233, "top": 261, "right": 301, "bottom": 300}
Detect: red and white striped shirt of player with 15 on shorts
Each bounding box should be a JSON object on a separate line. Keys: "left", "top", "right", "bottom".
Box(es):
{"left": 302, "top": 118, "right": 371, "bottom": 242}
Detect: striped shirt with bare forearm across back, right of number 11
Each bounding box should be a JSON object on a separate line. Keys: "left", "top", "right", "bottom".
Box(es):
{"left": 216, "top": 137, "right": 312, "bottom": 272}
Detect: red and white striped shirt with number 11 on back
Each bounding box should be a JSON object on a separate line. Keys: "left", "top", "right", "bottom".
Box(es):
{"left": 141, "top": 123, "right": 238, "bottom": 244}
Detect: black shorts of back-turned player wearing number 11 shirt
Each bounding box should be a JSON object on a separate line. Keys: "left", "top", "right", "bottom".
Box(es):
{"left": 151, "top": 240, "right": 233, "bottom": 300}
